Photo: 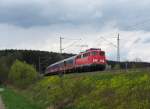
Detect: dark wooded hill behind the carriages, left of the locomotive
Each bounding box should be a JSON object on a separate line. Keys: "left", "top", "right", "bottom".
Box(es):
{"left": 0, "top": 49, "right": 73, "bottom": 73}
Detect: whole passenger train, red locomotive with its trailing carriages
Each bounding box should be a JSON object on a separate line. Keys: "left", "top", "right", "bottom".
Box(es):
{"left": 45, "top": 48, "right": 106, "bottom": 76}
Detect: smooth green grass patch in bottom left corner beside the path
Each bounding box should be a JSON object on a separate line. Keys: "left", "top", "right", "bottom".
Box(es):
{"left": 1, "top": 87, "right": 42, "bottom": 109}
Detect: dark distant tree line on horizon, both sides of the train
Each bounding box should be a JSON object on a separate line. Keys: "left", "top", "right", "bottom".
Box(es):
{"left": 0, "top": 49, "right": 150, "bottom": 73}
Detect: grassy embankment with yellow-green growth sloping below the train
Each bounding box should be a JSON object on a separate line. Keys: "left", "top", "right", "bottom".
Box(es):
{"left": 3, "top": 70, "right": 150, "bottom": 109}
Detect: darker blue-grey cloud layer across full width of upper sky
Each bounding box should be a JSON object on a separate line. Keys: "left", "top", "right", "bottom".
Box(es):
{"left": 0, "top": 0, "right": 150, "bottom": 30}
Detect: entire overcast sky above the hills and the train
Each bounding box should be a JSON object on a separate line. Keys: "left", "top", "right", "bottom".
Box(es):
{"left": 0, "top": 0, "right": 150, "bottom": 62}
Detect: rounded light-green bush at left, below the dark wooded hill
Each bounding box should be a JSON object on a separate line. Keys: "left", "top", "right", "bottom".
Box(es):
{"left": 8, "top": 60, "right": 37, "bottom": 88}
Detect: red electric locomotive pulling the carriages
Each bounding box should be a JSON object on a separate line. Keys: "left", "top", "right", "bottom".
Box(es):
{"left": 75, "top": 48, "right": 106, "bottom": 71}
